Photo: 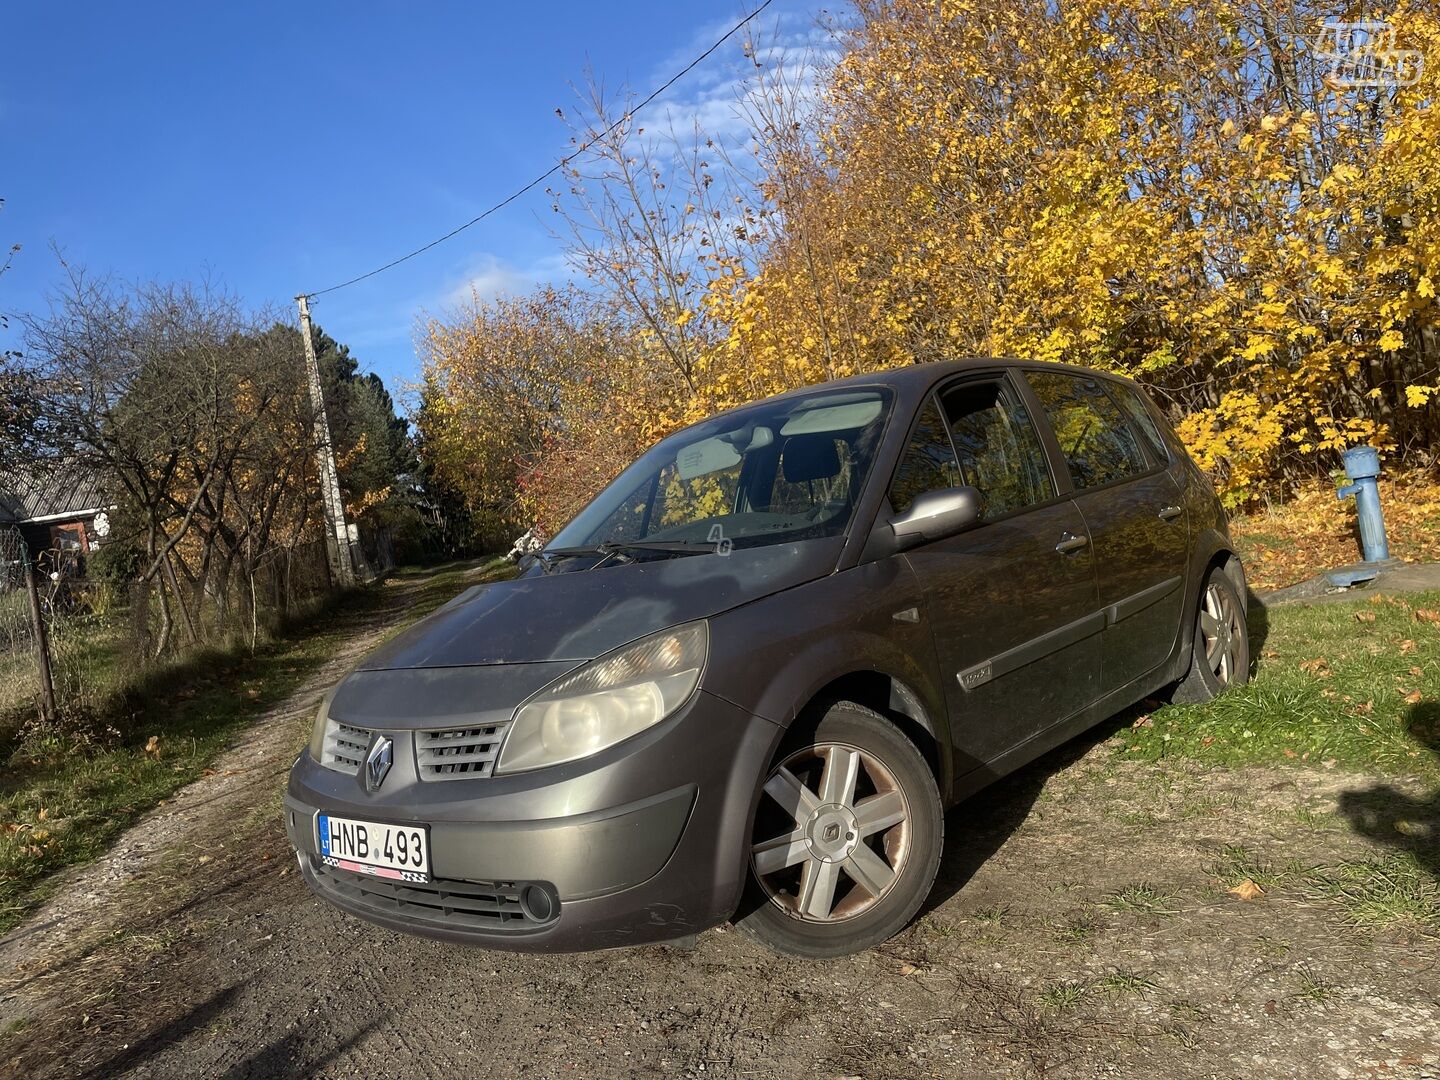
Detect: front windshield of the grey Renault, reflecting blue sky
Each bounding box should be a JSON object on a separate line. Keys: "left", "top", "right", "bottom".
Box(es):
{"left": 549, "top": 387, "right": 890, "bottom": 550}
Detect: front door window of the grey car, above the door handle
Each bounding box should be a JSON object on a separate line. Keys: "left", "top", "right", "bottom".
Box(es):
{"left": 940, "top": 382, "right": 1056, "bottom": 518}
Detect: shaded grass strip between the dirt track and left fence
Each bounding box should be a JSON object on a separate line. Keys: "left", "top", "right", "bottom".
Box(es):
{"left": 0, "top": 564, "right": 503, "bottom": 933}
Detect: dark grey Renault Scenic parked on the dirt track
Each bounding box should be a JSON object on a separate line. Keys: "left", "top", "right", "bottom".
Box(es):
{"left": 285, "top": 360, "right": 1248, "bottom": 956}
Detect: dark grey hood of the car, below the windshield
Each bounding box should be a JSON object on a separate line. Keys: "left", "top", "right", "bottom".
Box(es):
{"left": 359, "top": 537, "right": 844, "bottom": 671}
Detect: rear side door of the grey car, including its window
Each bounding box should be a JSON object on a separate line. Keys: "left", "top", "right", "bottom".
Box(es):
{"left": 1025, "top": 370, "right": 1189, "bottom": 693}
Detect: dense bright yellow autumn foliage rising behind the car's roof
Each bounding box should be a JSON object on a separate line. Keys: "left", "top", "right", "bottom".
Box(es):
{"left": 717, "top": 0, "right": 1440, "bottom": 501}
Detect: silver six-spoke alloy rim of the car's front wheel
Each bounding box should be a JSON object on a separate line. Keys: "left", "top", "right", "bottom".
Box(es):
{"left": 750, "top": 743, "right": 910, "bottom": 923}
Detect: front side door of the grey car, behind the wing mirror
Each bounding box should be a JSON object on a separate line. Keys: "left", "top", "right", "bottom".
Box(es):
{"left": 890, "top": 373, "right": 1103, "bottom": 776}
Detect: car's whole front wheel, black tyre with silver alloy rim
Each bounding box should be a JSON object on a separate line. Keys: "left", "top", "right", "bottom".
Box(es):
{"left": 736, "top": 701, "right": 945, "bottom": 959}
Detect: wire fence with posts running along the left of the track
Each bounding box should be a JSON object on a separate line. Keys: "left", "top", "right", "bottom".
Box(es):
{"left": 0, "top": 527, "right": 393, "bottom": 760}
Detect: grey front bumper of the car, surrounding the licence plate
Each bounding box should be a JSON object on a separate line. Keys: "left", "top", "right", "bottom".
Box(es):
{"left": 285, "top": 691, "right": 780, "bottom": 952}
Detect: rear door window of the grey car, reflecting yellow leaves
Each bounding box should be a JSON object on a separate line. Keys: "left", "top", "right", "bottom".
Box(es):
{"left": 1025, "top": 372, "right": 1149, "bottom": 491}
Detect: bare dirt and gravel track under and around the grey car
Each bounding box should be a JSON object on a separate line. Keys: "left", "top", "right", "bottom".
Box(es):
{"left": 0, "top": 570, "right": 1440, "bottom": 1079}
